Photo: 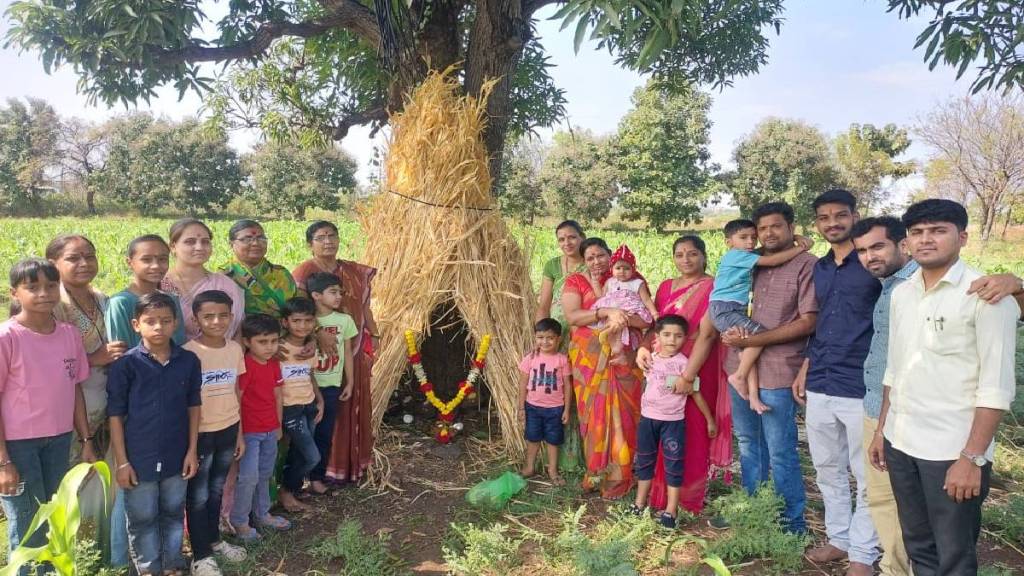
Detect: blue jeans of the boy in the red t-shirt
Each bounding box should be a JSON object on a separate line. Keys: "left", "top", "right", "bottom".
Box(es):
{"left": 230, "top": 431, "right": 278, "bottom": 526}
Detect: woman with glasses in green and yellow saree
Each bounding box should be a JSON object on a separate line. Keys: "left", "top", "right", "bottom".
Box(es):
{"left": 220, "top": 220, "right": 298, "bottom": 319}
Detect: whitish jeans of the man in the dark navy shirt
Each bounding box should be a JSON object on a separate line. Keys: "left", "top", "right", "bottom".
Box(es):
{"left": 807, "top": 392, "right": 879, "bottom": 566}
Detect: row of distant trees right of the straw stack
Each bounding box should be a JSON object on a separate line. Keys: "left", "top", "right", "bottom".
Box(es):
{"left": 499, "top": 82, "right": 1024, "bottom": 239}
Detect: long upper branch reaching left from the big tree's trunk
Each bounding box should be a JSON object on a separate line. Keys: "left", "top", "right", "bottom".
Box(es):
{"left": 154, "top": 0, "right": 380, "bottom": 66}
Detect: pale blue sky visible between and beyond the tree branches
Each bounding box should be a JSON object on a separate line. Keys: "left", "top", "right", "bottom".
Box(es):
{"left": 0, "top": 0, "right": 970, "bottom": 191}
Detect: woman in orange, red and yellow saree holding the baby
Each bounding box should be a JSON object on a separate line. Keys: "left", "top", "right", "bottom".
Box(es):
{"left": 562, "top": 238, "right": 647, "bottom": 499}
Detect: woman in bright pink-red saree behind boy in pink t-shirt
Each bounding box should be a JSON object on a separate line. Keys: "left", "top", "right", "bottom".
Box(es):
{"left": 640, "top": 236, "right": 732, "bottom": 515}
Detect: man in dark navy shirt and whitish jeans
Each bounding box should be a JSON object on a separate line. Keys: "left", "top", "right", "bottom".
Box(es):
{"left": 794, "top": 189, "right": 882, "bottom": 576}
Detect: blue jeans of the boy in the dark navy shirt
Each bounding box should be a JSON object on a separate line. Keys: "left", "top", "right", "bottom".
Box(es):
{"left": 124, "top": 475, "right": 188, "bottom": 574}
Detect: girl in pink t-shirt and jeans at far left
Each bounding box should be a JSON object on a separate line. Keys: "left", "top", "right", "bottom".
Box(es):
{"left": 0, "top": 258, "right": 90, "bottom": 551}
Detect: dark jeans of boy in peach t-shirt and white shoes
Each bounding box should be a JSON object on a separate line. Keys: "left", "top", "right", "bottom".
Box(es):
{"left": 185, "top": 423, "right": 236, "bottom": 560}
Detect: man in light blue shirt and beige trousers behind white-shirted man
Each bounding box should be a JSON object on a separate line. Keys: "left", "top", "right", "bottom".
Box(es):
{"left": 852, "top": 216, "right": 918, "bottom": 576}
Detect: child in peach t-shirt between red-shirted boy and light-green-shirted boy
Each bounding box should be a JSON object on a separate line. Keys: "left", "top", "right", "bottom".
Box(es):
{"left": 278, "top": 298, "right": 324, "bottom": 512}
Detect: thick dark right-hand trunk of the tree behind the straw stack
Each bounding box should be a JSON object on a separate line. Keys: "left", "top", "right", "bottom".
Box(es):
{"left": 465, "top": 0, "right": 530, "bottom": 182}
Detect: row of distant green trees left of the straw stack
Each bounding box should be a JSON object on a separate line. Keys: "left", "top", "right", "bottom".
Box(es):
{"left": 0, "top": 98, "right": 356, "bottom": 218}
